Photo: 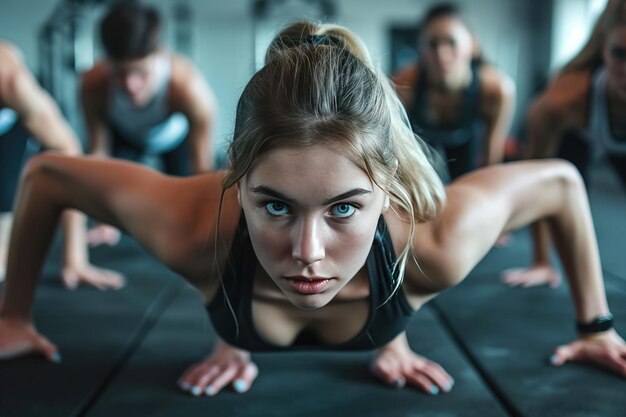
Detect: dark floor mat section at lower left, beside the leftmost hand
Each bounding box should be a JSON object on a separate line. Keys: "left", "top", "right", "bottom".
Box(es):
{"left": 0, "top": 239, "right": 182, "bottom": 417}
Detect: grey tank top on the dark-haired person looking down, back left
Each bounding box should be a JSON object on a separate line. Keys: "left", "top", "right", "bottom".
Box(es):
{"left": 107, "top": 53, "right": 189, "bottom": 153}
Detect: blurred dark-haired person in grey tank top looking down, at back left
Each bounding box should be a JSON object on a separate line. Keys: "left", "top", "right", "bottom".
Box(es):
{"left": 81, "top": 2, "right": 216, "bottom": 243}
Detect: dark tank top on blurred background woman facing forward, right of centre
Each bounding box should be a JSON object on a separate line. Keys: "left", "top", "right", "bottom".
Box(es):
{"left": 409, "top": 63, "right": 485, "bottom": 148}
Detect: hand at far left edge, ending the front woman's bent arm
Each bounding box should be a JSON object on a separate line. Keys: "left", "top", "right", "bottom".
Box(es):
{"left": 0, "top": 317, "right": 61, "bottom": 363}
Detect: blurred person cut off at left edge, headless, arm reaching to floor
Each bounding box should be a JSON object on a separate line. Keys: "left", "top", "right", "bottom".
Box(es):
{"left": 0, "top": 40, "right": 124, "bottom": 289}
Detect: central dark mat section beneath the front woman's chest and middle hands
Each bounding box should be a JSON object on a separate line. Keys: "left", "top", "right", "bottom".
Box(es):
{"left": 87, "top": 289, "right": 507, "bottom": 417}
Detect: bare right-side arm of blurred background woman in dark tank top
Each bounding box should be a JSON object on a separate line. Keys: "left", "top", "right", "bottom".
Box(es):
{"left": 480, "top": 67, "right": 515, "bottom": 165}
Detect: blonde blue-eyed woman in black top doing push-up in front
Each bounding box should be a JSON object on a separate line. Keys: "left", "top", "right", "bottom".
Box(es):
{"left": 0, "top": 23, "right": 626, "bottom": 396}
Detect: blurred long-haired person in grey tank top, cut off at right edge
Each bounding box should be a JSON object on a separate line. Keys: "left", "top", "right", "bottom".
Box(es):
{"left": 503, "top": 0, "right": 626, "bottom": 287}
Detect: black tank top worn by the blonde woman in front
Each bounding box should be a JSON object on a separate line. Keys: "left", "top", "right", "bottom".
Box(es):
{"left": 207, "top": 214, "right": 413, "bottom": 351}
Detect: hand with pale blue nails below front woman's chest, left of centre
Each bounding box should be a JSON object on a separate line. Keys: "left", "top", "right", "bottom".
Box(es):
{"left": 178, "top": 340, "right": 259, "bottom": 397}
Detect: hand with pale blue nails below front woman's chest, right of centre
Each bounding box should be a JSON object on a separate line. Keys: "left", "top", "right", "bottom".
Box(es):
{"left": 370, "top": 333, "right": 454, "bottom": 395}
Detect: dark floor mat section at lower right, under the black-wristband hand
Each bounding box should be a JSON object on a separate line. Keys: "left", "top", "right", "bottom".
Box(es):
{"left": 434, "top": 254, "right": 626, "bottom": 417}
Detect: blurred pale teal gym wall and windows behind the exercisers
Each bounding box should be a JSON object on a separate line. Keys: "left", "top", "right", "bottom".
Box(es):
{"left": 0, "top": 0, "right": 606, "bottom": 163}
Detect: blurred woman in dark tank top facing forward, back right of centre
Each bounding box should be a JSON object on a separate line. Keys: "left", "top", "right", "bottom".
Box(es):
{"left": 394, "top": 3, "right": 515, "bottom": 179}
